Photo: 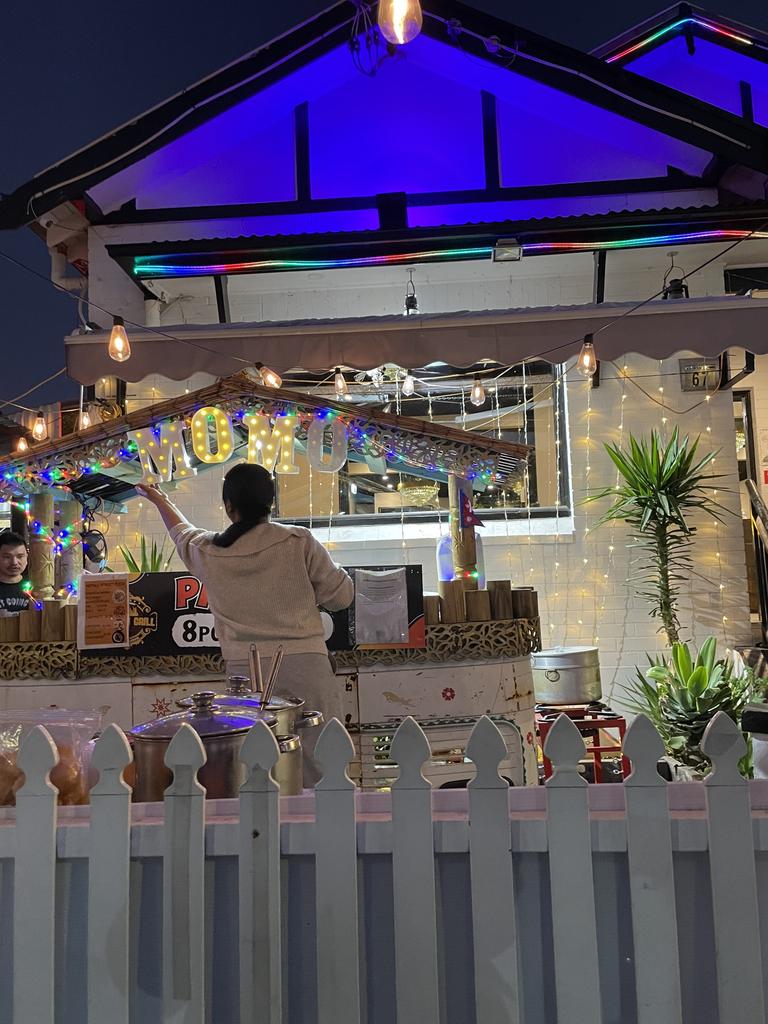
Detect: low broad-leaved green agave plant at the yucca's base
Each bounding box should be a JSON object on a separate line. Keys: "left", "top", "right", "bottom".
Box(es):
{"left": 623, "top": 637, "right": 755, "bottom": 773}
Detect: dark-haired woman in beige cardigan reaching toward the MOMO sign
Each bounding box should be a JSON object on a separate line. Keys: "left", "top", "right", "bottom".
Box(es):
{"left": 136, "top": 463, "right": 354, "bottom": 785}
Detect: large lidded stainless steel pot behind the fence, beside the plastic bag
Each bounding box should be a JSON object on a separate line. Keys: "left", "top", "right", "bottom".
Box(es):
{"left": 131, "top": 690, "right": 278, "bottom": 802}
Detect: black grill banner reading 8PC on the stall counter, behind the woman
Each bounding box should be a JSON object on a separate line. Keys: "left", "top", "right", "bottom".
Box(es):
{"left": 87, "top": 565, "right": 425, "bottom": 657}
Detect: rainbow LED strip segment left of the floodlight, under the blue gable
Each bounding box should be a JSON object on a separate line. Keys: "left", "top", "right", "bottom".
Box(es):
{"left": 133, "top": 246, "right": 494, "bottom": 278}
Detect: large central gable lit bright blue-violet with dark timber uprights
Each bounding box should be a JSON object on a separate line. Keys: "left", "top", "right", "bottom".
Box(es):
{"left": 91, "top": 28, "right": 711, "bottom": 220}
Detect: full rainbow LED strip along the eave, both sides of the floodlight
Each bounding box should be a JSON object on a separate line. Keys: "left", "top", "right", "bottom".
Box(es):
{"left": 133, "top": 228, "right": 768, "bottom": 278}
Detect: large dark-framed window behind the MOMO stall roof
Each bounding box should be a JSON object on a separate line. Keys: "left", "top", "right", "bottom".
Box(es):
{"left": 275, "top": 362, "right": 568, "bottom": 525}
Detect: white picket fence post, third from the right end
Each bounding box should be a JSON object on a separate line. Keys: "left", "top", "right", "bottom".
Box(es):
{"left": 544, "top": 715, "right": 603, "bottom": 1024}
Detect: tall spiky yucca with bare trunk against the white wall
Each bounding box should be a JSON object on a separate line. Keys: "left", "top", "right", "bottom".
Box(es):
{"left": 587, "top": 430, "right": 726, "bottom": 646}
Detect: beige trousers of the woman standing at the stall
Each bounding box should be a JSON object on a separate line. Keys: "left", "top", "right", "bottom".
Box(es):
{"left": 226, "top": 653, "right": 344, "bottom": 788}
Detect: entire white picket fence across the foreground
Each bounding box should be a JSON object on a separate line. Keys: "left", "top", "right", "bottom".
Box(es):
{"left": 0, "top": 715, "right": 768, "bottom": 1024}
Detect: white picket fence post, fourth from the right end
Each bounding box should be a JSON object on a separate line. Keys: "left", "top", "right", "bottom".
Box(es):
{"left": 466, "top": 716, "right": 520, "bottom": 1024}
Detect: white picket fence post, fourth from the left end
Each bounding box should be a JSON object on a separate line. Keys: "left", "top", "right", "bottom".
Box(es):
{"left": 239, "top": 722, "right": 283, "bottom": 1024}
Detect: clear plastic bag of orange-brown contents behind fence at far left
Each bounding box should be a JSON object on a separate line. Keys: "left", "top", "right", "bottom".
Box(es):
{"left": 0, "top": 708, "right": 103, "bottom": 807}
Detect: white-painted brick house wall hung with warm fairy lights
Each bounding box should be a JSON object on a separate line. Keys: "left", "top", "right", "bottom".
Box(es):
{"left": 91, "top": 236, "right": 768, "bottom": 705}
